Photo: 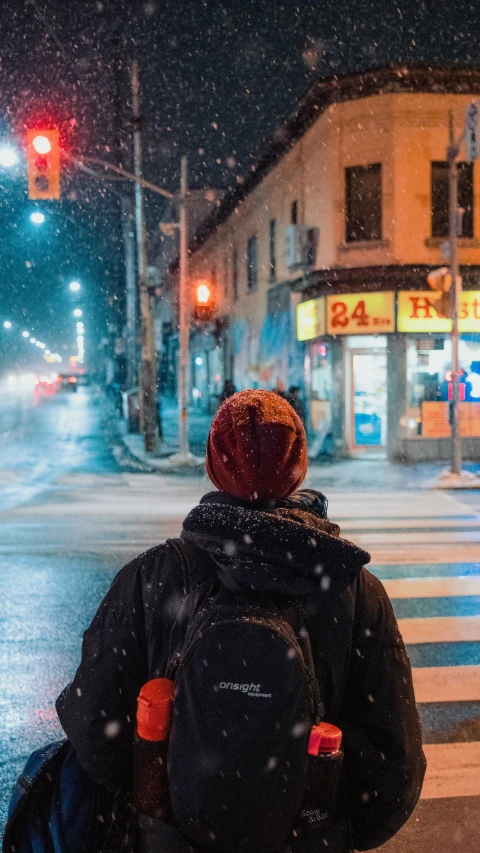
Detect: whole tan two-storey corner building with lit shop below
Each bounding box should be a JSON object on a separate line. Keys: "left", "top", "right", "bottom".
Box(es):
{"left": 181, "top": 66, "right": 480, "bottom": 461}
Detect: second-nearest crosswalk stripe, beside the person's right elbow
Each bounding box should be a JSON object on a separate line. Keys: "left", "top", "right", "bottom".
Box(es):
{"left": 412, "top": 665, "right": 480, "bottom": 703}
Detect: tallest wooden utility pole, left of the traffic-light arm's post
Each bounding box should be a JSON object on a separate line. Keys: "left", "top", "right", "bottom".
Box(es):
{"left": 131, "top": 61, "right": 157, "bottom": 453}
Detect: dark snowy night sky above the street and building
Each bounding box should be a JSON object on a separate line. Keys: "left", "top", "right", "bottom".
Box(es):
{"left": 0, "top": 0, "right": 480, "bottom": 369}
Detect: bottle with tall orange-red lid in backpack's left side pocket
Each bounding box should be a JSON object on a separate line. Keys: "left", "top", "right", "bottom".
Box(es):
{"left": 133, "top": 678, "right": 175, "bottom": 820}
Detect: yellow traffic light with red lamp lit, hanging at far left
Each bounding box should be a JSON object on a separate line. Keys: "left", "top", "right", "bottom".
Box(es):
{"left": 27, "top": 127, "right": 60, "bottom": 201}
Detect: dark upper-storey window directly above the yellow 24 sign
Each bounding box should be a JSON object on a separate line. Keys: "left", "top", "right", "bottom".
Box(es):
{"left": 345, "top": 163, "right": 382, "bottom": 243}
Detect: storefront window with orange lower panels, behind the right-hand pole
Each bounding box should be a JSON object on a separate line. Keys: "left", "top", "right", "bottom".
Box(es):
{"left": 402, "top": 335, "right": 480, "bottom": 438}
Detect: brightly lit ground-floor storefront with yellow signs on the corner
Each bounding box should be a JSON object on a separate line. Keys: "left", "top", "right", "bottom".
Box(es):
{"left": 297, "top": 290, "right": 480, "bottom": 461}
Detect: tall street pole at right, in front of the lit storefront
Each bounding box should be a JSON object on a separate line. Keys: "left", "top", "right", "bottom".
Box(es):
{"left": 447, "top": 113, "right": 462, "bottom": 474}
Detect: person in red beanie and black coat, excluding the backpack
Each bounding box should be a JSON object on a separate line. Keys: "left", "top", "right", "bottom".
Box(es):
{"left": 57, "top": 391, "right": 426, "bottom": 853}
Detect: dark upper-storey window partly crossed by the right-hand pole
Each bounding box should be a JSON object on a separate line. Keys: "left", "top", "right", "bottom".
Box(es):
{"left": 432, "top": 161, "right": 473, "bottom": 237}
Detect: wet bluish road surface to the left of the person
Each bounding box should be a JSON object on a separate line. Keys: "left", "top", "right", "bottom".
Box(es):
{"left": 0, "top": 388, "right": 205, "bottom": 826}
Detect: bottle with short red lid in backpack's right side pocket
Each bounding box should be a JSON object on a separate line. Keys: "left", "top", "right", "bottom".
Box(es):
{"left": 295, "top": 723, "right": 343, "bottom": 835}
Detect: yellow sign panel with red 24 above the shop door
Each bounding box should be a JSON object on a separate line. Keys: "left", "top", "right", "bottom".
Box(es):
{"left": 327, "top": 293, "right": 395, "bottom": 335}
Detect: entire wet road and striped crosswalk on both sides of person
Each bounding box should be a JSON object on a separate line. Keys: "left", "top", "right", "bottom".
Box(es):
{"left": 0, "top": 384, "right": 480, "bottom": 853}
